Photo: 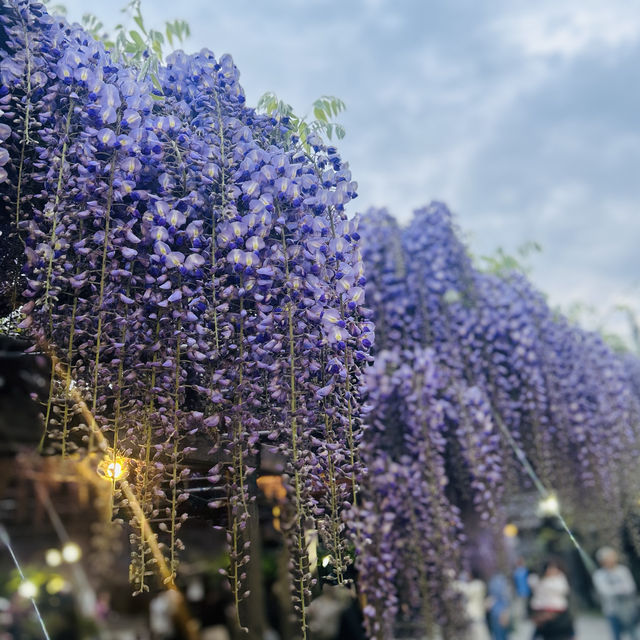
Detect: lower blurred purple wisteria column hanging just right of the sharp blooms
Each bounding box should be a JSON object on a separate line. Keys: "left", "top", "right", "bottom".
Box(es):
{"left": 356, "top": 346, "right": 470, "bottom": 638}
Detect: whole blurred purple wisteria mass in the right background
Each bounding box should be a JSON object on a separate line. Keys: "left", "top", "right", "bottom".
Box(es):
{"left": 358, "top": 203, "right": 640, "bottom": 638}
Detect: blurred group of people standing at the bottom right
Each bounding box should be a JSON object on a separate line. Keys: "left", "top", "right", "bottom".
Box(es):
{"left": 458, "top": 547, "right": 640, "bottom": 640}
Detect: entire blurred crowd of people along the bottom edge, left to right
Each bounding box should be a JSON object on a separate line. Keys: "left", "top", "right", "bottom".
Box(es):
{"left": 0, "top": 547, "right": 640, "bottom": 640}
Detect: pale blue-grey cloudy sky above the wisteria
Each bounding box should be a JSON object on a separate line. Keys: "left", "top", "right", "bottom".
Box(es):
{"left": 64, "top": 0, "right": 640, "bottom": 344}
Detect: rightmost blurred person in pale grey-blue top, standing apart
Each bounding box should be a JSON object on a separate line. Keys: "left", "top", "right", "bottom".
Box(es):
{"left": 593, "top": 547, "right": 640, "bottom": 640}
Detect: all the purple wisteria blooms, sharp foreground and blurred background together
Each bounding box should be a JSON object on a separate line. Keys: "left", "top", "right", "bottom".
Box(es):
{"left": 0, "top": 0, "right": 640, "bottom": 638}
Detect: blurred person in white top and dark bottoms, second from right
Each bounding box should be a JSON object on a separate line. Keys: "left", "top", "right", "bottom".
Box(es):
{"left": 531, "top": 560, "right": 575, "bottom": 640}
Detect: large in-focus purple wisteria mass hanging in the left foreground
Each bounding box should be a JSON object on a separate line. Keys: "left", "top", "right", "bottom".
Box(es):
{"left": 0, "top": 0, "right": 373, "bottom": 632}
